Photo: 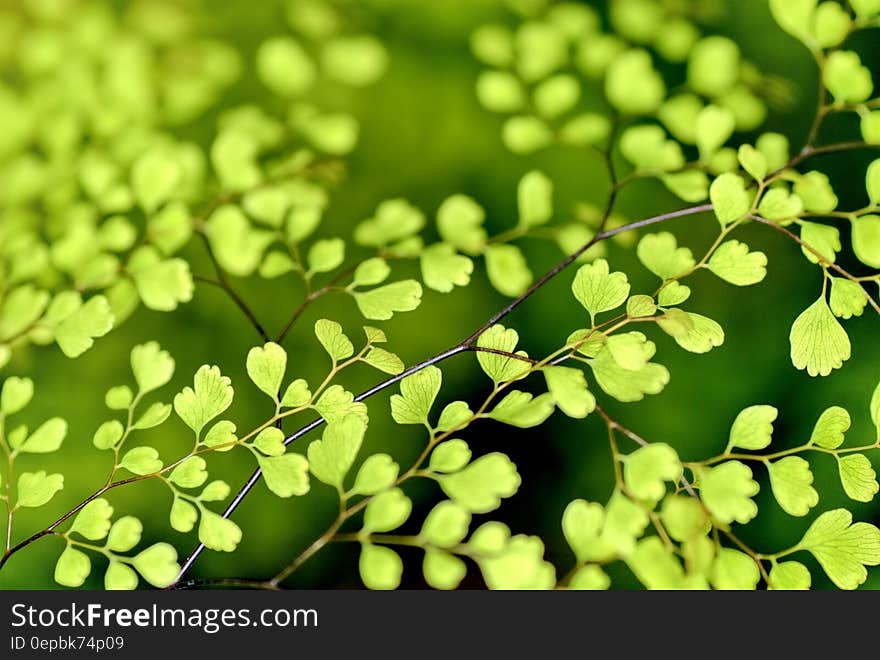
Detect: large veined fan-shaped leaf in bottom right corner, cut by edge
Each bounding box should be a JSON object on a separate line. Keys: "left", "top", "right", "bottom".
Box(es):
{"left": 797, "top": 509, "right": 880, "bottom": 589}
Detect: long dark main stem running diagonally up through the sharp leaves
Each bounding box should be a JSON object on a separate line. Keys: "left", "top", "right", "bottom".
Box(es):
{"left": 177, "top": 204, "right": 713, "bottom": 581}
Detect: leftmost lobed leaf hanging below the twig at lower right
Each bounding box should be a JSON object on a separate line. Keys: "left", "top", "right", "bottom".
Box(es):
{"left": 698, "top": 461, "right": 759, "bottom": 524}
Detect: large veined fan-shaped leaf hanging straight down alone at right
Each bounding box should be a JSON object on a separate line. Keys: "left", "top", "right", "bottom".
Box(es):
{"left": 789, "top": 296, "right": 850, "bottom": 376}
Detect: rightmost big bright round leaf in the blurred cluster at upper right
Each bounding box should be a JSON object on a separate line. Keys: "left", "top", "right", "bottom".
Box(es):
{"left": 605, "top": 49, "right": 666, "bottom": 115}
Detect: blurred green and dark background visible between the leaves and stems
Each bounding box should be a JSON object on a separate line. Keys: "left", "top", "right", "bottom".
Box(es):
{"left": 0, "top": 0, "right": 880, "bottom": 589}
